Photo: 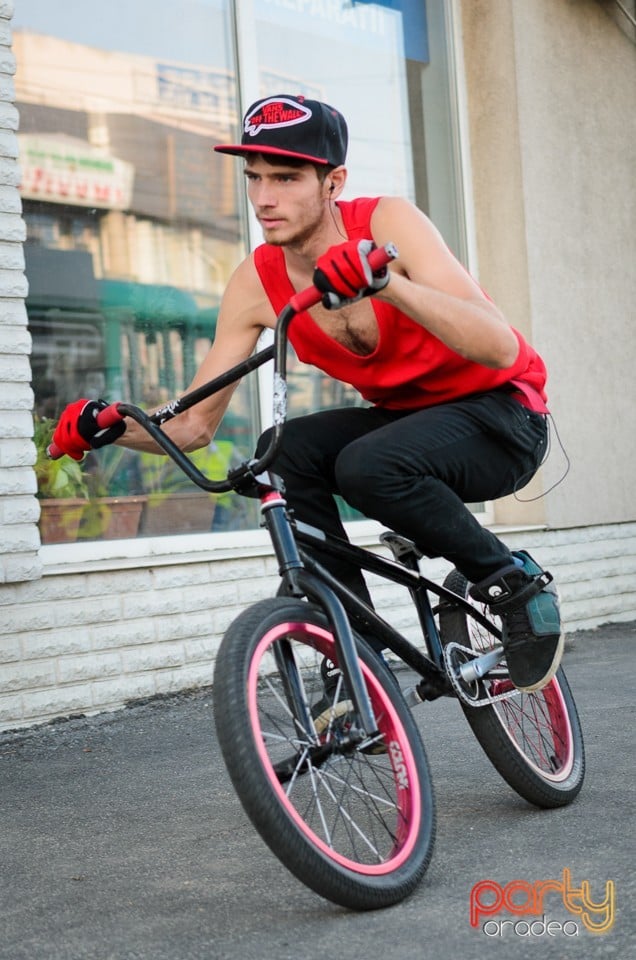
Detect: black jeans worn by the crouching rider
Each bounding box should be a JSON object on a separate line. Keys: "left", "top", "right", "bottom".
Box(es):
{"left": 257, "top": 390, "right": 547, "bottom": 598}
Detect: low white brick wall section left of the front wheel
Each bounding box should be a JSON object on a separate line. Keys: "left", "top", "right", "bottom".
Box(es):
{"left": 0, "top": 557, "right": 275, "bottom": 729}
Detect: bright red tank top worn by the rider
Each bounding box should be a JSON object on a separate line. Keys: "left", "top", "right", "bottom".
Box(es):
{"left": 254, "top": 197, "right": 547, "bottom": 413}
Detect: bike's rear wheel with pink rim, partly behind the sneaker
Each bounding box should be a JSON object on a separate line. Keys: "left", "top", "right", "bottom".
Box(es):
{"left": 440, "top": 570, "right": 585, "bottom": 808}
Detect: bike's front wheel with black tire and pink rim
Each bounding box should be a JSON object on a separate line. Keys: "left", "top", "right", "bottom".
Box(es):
{"left": 214, "top": 597, "right": 435, "bottom": 910}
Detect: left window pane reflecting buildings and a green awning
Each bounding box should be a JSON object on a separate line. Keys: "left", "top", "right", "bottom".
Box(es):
{"left": 14, "top": 0, "right": 258, "bottom": 541}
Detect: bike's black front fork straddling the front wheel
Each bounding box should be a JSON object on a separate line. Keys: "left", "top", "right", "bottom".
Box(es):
{"left": 255, "top": 473, "right": 379, "bottom": 743}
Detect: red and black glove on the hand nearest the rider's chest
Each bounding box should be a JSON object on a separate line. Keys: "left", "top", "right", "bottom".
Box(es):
{"left": 314, "top": 240, "right": 389, "bottom": 310}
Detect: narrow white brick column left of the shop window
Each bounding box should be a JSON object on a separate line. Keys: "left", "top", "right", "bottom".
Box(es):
{"left": 0, "top": 0, "right": 42, "bottom": 584}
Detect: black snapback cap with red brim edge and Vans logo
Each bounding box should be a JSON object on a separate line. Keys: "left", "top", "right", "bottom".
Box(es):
{"left": 214, "top": 94, "right": 349, "bottom": 167}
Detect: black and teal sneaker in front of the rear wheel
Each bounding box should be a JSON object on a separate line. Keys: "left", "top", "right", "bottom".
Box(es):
{"left": 470, "top": 550, "right": 563, "bottom": 693}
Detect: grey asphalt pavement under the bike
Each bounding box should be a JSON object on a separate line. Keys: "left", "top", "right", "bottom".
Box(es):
{"left": 0, "top": 622, "right": 636, "bottom": 960}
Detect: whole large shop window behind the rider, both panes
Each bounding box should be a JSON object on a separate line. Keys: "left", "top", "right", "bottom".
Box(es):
{"left": 14, "top": 0, "right": 476, "bottom": 539}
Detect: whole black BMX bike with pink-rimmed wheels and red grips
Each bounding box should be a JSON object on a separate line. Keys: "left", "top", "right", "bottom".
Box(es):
{"left": 51, "top": 245, "right": 585, "bottom": 910}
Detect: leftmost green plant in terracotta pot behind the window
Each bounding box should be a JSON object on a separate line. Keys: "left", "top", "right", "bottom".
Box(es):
{"left": 33, "top": 417, "right": 89, "bottom": 543}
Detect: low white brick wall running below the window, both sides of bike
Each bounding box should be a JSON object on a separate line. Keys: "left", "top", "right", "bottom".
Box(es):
{"left": 0, "top": 523, "right": 636, "bottom": 729}
